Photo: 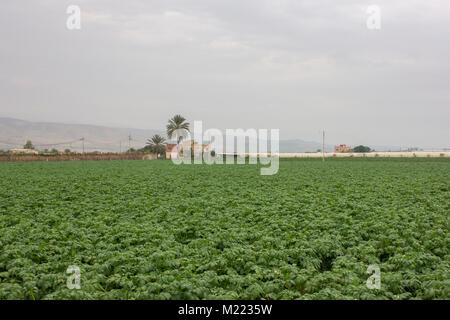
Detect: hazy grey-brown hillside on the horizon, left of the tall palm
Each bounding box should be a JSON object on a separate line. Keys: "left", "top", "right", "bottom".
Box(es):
{"left": 0, "top": 118, "right": 164, "bottom": 152}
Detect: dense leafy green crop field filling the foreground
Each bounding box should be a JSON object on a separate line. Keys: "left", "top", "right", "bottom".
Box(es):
{"left": 0, "top": 159, "right": 450, "bottom": 299}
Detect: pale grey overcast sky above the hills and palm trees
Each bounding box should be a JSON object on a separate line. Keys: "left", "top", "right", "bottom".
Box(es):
{"left": 0, "top": 0, "right": 450, "bottom": 147}
